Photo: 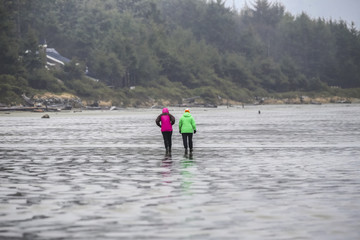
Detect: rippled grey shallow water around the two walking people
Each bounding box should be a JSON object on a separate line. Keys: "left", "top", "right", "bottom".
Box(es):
{"left": 0, "top": 104, "right": 360, "bottom": 240}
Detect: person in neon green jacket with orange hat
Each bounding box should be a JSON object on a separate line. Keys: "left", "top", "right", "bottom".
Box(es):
{"left": 179, "top": 109, "right": 196, "bottom": 153}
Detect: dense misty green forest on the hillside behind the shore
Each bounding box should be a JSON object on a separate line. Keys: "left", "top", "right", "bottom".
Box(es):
{"left": 0, "top": 0, "right": 360, "bottom": 106}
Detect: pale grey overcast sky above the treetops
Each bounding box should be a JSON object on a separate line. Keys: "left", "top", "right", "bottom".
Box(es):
{"left": 226, "top": 0, "right": 360, "bottom": 30}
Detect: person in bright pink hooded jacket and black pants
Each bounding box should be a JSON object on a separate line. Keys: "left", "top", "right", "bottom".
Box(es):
{"left": 155, "top": 108, "right": 175, "bottom": 154}
